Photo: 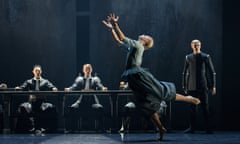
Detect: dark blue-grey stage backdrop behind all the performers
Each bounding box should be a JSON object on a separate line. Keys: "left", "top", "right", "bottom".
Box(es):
{"left": 0, "top": 0, "right": 227, "bottom": 129}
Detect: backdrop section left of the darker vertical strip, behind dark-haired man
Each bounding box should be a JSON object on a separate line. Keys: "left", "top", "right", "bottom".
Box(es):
{"left": 0, "top": 0, "right": 76, "bottom": 88}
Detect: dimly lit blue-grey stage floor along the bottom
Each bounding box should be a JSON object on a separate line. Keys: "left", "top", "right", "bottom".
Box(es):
{"left": 0, "top": 131, "right": 240, "bottom": 144}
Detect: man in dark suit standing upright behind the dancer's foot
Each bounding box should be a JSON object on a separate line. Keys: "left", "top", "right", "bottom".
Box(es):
{"left": 182, "top": 40, "right": 216, "bottom": 133}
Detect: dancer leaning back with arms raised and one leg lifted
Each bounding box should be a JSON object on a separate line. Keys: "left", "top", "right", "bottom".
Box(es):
{"left": 102, "top": 14, "right": 200, "bottom": 140}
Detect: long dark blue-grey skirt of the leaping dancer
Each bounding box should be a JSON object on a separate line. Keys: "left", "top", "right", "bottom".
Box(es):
{"left": 122, "top": 67, "right": 176, "bottom": 118}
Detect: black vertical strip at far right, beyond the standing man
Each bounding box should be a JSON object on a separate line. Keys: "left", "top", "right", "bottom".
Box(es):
{"left": 220, "top": 0, "right": 240, "bottom": 130}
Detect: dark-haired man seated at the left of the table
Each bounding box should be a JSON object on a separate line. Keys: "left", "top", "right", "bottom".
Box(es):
{"left": 15, "top": 65, "right": 58, "bottom": 133}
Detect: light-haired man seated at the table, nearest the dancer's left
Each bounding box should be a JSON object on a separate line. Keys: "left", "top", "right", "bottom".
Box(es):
{"left": 65, "top": 64, "right": 107, "bottom": 130}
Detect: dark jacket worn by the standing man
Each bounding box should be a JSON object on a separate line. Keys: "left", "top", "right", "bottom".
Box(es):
{"left": 182, "top": 52, "right": 216, "bottom": 91}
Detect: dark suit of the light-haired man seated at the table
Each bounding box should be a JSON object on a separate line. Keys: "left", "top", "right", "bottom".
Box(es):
{"left": 66, "top": 76, "right": 104, "bottom": 131}
